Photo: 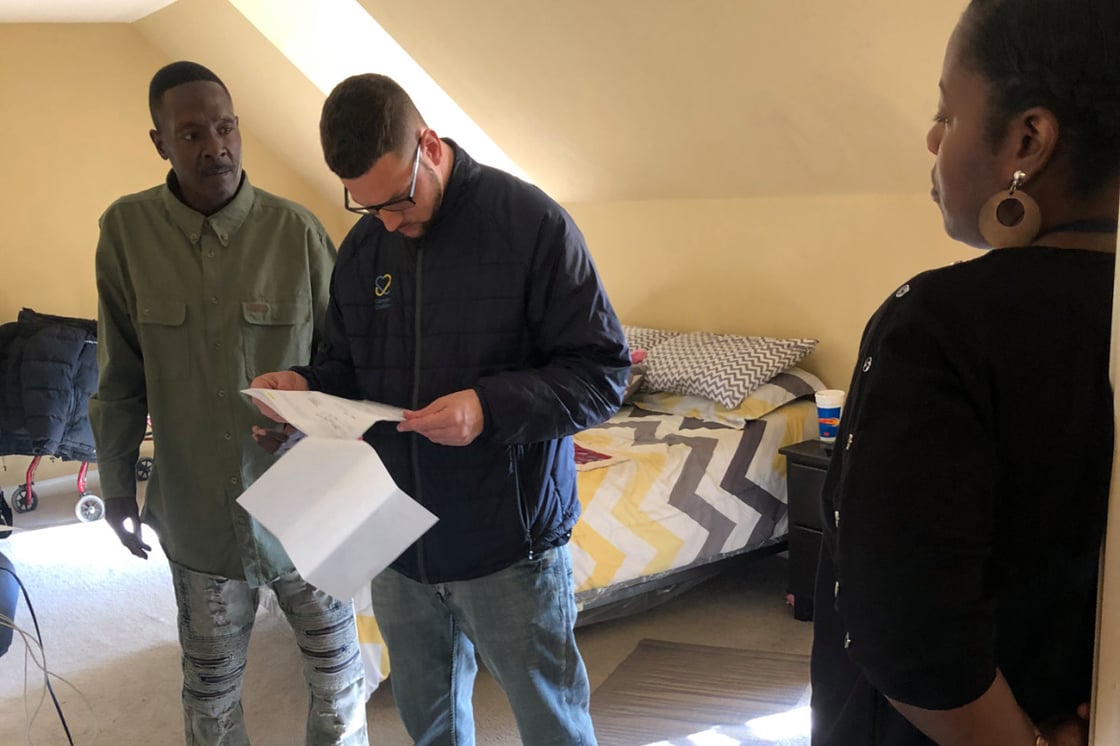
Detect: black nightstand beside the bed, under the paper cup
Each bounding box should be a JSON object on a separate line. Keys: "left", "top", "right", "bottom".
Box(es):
{"left": 778, "top": 440, "right": 834, "bottom": 622}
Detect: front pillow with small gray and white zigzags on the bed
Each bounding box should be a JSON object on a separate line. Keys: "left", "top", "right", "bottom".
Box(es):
{"left": 642, "top": 332, "right": 816, "bottom": 408}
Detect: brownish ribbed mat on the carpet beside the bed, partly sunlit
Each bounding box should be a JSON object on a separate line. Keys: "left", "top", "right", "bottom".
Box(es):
{"left": 591, "top": 640, "right": 809, "bottom": 746}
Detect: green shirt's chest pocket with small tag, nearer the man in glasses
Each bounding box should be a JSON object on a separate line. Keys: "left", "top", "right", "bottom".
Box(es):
{"left": 241, "top": 299, "right": 315, "bottom": 381}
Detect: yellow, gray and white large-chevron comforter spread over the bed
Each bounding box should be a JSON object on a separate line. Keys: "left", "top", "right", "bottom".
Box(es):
{"left": 354, "top": 400, "right": 816, "bottom": 693}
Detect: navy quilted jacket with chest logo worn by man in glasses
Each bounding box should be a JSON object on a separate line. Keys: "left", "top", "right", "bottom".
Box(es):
{"left": 299, "top": 143, "right": 629, "bottom": 582}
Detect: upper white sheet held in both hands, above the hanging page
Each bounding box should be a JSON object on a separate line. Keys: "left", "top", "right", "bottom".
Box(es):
{"left": 241, "top": 389, "right": 404, "bottom": 440}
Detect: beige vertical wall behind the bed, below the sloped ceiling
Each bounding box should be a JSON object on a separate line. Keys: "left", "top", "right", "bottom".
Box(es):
{"left": 568, "top": 195, "right": 976, "bottom": 389}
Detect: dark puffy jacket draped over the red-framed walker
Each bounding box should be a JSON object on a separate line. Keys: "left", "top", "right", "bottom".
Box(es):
{"left": 0, "top": 308, "right": 97, "bottom": 461}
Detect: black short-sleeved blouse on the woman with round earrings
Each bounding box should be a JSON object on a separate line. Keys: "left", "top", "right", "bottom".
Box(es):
{"left": 812, "top": 248, "right": 1113, "bottom": 746}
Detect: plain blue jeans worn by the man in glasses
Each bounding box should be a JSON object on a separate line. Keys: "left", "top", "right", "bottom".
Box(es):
{"left": 370, "top": 547, "right": 596, "bottom": 746}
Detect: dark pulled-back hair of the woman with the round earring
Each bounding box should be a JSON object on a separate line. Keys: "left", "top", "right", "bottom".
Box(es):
{"left": 961, "top": 0, "right": 1120, "bottom": 196}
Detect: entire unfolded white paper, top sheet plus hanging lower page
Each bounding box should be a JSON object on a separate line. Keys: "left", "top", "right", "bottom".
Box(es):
{"left": 237, "top": 389, "right": 438, "bottom": 598}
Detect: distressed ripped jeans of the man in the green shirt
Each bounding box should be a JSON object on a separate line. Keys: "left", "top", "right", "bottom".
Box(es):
{"left": 170, "top": 562, "right": 368, "bottom": 746}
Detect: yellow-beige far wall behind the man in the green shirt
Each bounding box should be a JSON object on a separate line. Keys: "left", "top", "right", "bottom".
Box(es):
{"left": 0, "top": 24, "right": 349, "bottom": 488}
